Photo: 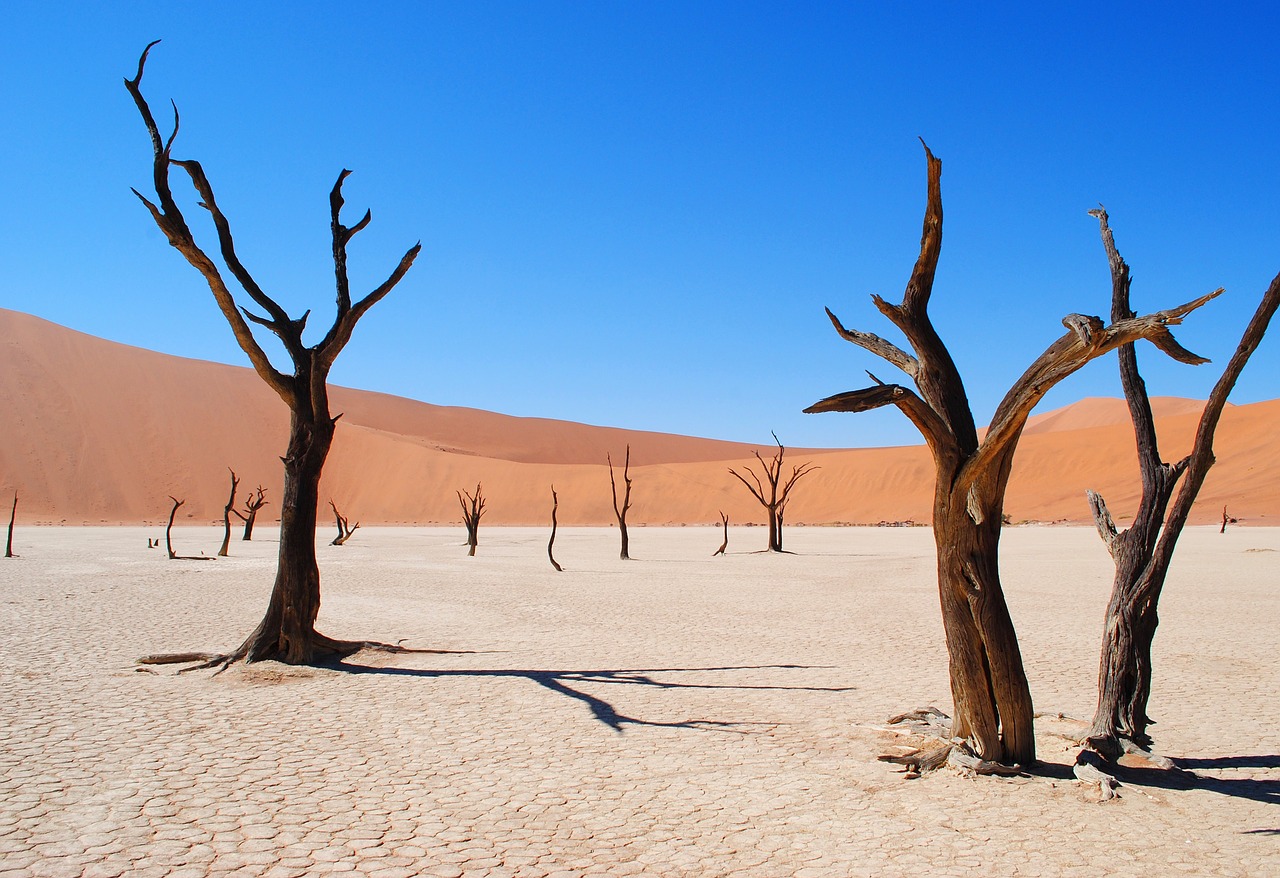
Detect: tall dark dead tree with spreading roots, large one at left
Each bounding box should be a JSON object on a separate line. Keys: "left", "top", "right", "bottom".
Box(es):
{"left": 124, "top": 44, "right": 421, "bottom": 667}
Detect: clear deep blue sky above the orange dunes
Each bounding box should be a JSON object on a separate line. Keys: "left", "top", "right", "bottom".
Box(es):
{"left": 0, "top": 0, "right": 1280, "bottom": 447}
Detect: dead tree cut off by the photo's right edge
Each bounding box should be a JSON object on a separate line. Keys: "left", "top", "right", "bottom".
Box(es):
{"left": 1087, "top": 210, "right": 1280, "bottom": 759}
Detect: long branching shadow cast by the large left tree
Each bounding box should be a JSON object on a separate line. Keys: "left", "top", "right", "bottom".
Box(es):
{"left": 321, "top": 660, "right": 854, "bottom": 735}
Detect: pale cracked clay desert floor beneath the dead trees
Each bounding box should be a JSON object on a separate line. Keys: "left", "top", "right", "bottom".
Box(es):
{"left": 0, "top": 526, "right": 1280, "bottom": 878}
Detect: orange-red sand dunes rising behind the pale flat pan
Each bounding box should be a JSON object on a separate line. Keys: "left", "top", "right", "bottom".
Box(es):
{"left": 0, "top": 310, "right": 1280, "bottom": 525}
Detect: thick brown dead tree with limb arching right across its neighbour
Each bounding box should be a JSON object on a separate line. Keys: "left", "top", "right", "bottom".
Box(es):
{"left": 805, "top": 147, "right": 1221, "bottom": 765}
